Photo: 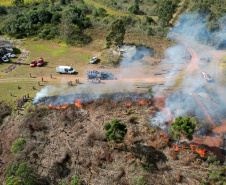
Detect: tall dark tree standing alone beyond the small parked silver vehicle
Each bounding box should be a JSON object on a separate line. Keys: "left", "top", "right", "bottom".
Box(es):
{"left": 106, "top": 19, "right": 126, "bottom": 47}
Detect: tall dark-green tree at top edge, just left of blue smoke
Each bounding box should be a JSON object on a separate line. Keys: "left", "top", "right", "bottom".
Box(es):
{"left": 157, "top": 0, "right": 177, "bottom": 27}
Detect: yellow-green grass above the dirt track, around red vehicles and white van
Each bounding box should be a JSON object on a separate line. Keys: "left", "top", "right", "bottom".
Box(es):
{"left": 1, "top": 40, "right": 95, "bottom": 78}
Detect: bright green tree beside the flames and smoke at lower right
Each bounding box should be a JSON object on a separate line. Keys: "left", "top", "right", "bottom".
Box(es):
{"left": 169, "top": 116, "right": 196, "bottom": 145}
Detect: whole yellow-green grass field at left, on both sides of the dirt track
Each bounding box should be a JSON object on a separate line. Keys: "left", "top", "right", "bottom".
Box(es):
{"left": 0, "top": 40, "right": 95, "bottom": 104}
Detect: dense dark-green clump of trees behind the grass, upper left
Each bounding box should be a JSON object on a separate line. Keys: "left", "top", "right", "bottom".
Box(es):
{"left": 0, "top": 0, "right": 91, "bottom": 44}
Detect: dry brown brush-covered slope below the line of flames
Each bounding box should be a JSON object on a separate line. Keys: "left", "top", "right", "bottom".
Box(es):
{"left": 0, "top": 101, "right": 212, "bottom": 184}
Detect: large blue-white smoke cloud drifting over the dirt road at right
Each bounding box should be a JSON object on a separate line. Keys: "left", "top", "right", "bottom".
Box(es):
{"left": 152, "top": 14, "right": 226, "bottom": 130}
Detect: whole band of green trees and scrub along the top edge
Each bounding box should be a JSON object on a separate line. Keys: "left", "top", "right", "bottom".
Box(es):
{"left": 0, "top": 0, "right": 226, "bottom": 45}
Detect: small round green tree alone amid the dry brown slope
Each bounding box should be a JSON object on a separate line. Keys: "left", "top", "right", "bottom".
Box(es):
{"left": 104, "top": 119, "right": 127, "bottom": 147}
